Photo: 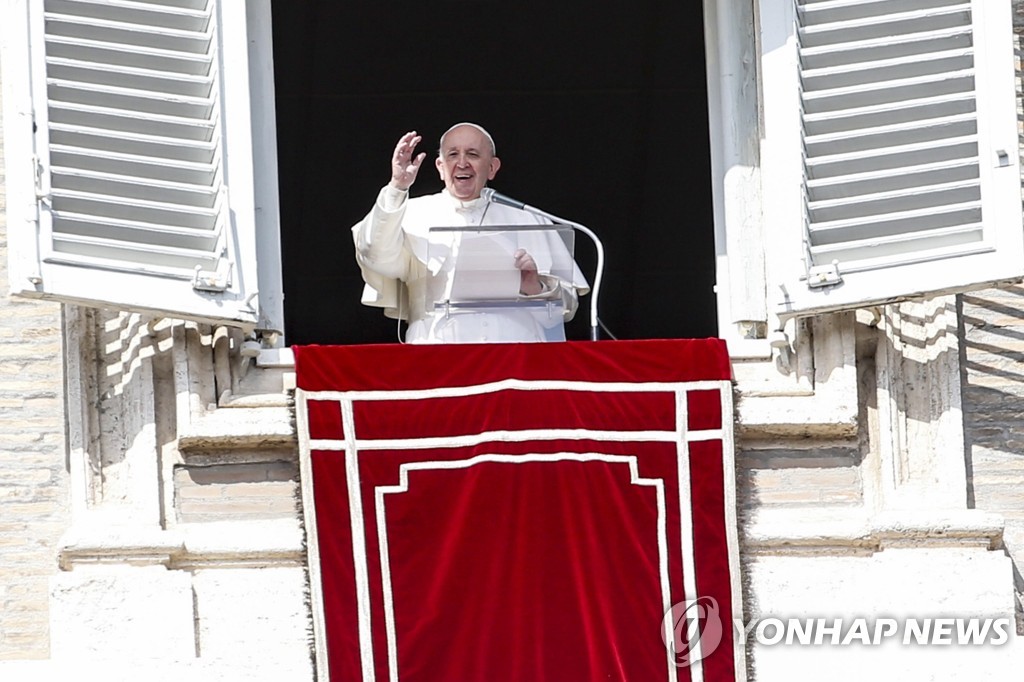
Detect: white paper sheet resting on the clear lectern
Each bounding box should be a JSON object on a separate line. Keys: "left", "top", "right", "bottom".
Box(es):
{"left": 450, "top": 232, "right": 521, "bottom": 301}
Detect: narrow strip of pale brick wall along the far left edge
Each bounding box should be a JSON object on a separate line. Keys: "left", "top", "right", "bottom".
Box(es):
{"left": 0, "top": 63, "right": 69, "bottom": 660}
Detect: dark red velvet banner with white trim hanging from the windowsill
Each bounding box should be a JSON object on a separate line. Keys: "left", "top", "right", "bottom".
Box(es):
{"left": 295, "top": 339, "right": 744, "bottom": 682}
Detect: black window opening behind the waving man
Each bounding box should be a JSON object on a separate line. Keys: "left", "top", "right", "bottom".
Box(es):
{"left": 272, "top": 0, "right": 717, "bottom": 344}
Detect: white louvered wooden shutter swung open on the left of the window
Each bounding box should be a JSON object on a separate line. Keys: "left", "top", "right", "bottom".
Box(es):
{"left": 5, "top": 0, "right": 276, "bottom": 327}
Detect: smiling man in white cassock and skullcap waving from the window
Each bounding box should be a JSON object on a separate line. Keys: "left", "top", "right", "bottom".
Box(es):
{"left": 352, "top": 123, "right": 589, "bottom": 343}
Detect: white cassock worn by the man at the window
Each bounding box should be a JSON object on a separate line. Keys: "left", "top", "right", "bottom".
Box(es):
{"left": 352, "top": 185, "right": 589, "bottom": 343}
